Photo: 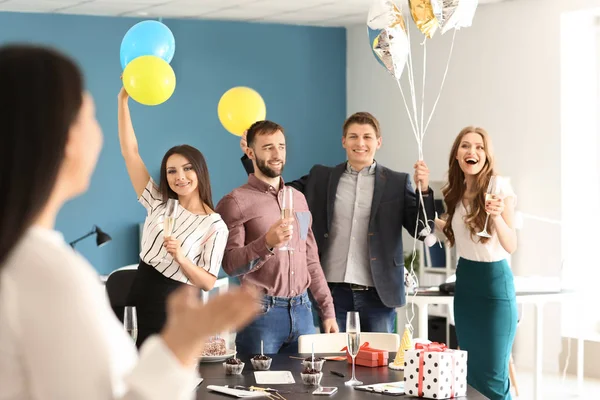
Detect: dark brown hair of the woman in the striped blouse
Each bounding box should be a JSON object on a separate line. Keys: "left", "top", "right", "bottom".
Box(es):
{"left": 159, "top": 144, "right": 214, "bottom": 210}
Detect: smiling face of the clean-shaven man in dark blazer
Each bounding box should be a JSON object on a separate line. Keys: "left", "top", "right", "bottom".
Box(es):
{"left": 342, "top": 123, "right": 381, "bottom": 171}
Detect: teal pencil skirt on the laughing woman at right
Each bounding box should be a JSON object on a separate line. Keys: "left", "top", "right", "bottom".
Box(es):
{"left": 454, "top": 258, "right": 517, "bottom": 400}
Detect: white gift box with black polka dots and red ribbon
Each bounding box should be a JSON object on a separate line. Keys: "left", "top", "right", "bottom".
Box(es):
{"left": 404, "top": 343, "right": 467, "bottom": 399}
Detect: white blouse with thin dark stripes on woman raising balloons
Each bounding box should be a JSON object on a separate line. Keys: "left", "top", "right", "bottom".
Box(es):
{"left": 138, "top": 178, "right": 229, "bottom": 283}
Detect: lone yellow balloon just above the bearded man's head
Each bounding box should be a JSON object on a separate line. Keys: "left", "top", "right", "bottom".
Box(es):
{"left": 217, "top": 86, "right": 267, "bottom": 136}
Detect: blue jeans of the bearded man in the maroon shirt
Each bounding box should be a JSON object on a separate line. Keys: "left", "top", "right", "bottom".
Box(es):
{"left": 235, "top": 292, "right": 316, "bottom": 356}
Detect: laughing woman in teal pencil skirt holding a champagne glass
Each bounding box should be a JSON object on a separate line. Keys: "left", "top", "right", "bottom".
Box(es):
{"left": 435, "top": 127, "right": 517, "bottom": 400}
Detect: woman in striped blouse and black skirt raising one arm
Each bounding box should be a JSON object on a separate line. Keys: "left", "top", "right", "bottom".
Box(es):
{"left": 118, "top": 88, "right": 229, "bottom": 347}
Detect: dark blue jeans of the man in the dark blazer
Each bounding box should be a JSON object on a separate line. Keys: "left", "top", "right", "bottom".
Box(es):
{"left": 329, "top": 283, "right": 396, "bottom": 333}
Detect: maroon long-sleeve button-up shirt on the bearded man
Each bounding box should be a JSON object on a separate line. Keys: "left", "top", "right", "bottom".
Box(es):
{"left": 215, "top": 174, "right": 335, "bottom": 319}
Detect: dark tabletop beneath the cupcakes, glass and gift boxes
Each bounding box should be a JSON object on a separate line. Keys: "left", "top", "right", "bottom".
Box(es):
{"left": 196, "top": 353, "right": 485, "bottom": 400}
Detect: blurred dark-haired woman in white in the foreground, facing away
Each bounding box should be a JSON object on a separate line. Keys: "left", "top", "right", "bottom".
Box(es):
{"left": 0, "top": 44, "right": 258, "bottom": 400}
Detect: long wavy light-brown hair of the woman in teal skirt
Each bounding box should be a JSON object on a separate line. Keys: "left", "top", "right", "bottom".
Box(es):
{"left": 442, "top": 126, "right": 494, "bottom": 246}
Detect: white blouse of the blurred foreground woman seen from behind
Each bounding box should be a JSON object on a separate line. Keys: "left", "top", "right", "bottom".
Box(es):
{"left": 0, "top": 227, "right": 198, "bottom": 400}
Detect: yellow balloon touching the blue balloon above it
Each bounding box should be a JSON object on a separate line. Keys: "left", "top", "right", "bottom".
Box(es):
{"left": 123, "top": 56, "right": 175, "bottom": 106}
